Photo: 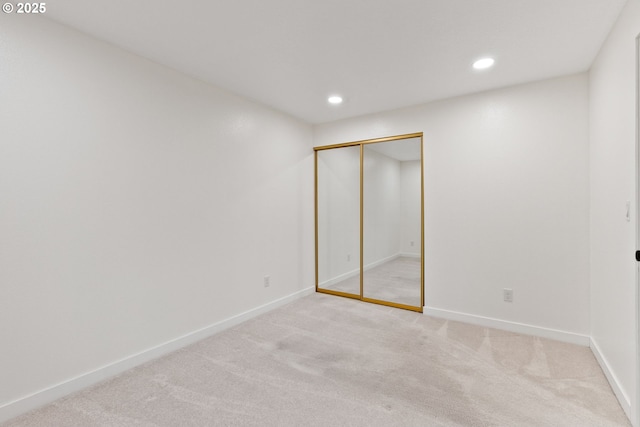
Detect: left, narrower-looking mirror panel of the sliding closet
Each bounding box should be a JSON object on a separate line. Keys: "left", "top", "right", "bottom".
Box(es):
{"left": 316, "top": 146, "right": 360, "bottom": 298}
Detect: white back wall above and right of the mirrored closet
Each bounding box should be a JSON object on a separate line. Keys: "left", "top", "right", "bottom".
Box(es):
{"left": 314, "top": 74, "right": 589, "bottom": 342}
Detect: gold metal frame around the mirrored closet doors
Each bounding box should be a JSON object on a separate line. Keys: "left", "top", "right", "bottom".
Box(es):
{"left": 313, "top": 132, "right": 424, "bottom": 313}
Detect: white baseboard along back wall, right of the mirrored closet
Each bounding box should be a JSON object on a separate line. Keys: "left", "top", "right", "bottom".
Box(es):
{"left": 424, "top": 307, "right": 591, "bottom": 347}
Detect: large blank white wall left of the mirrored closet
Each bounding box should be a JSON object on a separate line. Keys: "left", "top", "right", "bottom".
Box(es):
{"left": 0, "top": 15, "right": 314, "bottom": 420}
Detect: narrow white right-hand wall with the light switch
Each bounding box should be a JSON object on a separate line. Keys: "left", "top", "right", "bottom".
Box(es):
{"left": 589, "top": 0, "right": 640, "bottom": 425}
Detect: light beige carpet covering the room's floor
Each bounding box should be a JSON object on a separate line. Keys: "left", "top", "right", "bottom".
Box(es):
{"left": 5, "top": 294, "right": 630, "bottom": 427}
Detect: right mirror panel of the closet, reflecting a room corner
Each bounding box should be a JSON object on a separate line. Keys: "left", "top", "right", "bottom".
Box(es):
{"left": 363, "top": 137, "right": 422, "bottom": 308}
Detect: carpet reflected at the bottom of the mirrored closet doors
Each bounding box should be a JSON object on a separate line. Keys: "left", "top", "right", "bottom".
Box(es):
{"left": 327, "top": 257, "right": 420, "bottom": 307}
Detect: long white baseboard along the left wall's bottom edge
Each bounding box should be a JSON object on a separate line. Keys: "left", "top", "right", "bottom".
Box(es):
{"left": 0, "top": 287, "right": 315, "bottom": 423}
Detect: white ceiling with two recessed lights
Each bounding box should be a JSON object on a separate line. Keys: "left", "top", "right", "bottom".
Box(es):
{"left": 46, "top": 0, "right": 633, "bottom": 123}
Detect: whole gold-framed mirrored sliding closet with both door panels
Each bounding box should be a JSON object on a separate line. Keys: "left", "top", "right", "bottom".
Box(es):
{"left": 315, "top": 133, "right": 424, "bottom": 312}
